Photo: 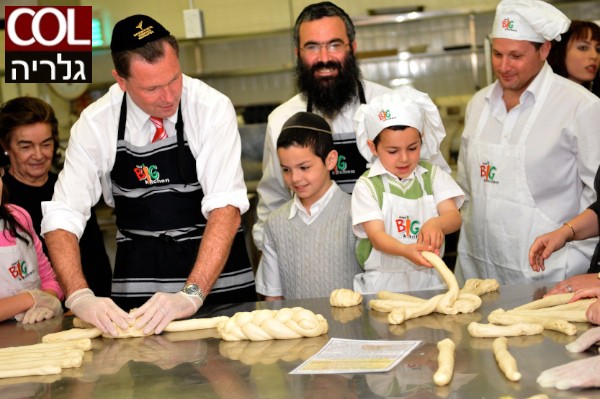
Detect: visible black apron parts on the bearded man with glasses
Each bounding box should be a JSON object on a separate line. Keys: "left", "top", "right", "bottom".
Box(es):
{"left": 306, "top": 81, "right": 367, "bottom": 194}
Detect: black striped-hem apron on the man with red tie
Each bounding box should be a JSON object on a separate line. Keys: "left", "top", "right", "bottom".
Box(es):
{"left": 110, "top": 95, "right": 256, "bottom": 310}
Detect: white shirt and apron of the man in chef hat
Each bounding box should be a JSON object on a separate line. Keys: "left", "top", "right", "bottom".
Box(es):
{"left": 456, "top": 63, "right": 600, "bottom": 284}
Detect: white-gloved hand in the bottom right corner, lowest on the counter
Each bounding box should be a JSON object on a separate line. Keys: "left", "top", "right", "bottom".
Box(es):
{"left": 537, "top": 356, "right": 600, "bottom": 390}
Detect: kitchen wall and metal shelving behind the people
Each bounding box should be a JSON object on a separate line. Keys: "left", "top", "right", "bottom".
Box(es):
{"left": 0, "top": 0, "right": 600, "bottom": 268}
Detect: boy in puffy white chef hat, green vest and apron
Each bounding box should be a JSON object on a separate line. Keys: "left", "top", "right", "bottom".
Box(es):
{"left": 352, "top": 87, "right": 464, "bottom": 294}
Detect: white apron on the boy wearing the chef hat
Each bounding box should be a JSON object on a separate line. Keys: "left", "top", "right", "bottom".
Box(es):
{"left": 354, "top": 173, "right": 445, "bottom": 294}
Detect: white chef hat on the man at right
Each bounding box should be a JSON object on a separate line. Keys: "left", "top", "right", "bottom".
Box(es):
{"left": 492, "top": 0, "right": 571, "bottom": 43}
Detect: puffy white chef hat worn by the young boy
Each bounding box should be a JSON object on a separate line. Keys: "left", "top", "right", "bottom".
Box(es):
{"left": 354, "top": 86, "right": 446, "bottom": 163}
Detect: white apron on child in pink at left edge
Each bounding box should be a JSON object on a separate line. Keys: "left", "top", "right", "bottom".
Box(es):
{"left": 0, "top": 227, "right": 41, "bottom": 298}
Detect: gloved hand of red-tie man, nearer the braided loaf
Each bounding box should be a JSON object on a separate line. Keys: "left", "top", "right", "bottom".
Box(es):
{"left": 130, "top": 292, "right": 202, "bottom": 334}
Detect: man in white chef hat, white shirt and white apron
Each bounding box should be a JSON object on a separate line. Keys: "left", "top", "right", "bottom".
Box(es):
{"left": 455, "top": 0, "right": 600, "bottom": 292}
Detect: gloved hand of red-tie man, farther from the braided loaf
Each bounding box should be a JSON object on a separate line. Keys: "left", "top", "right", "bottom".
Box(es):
{"left": 65, "top": 288, "right": 133, "bottom": 337}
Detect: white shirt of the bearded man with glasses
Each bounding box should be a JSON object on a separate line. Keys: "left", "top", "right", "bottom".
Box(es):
{"left": 252, "top": 80, "right": 391, "bottom": 250}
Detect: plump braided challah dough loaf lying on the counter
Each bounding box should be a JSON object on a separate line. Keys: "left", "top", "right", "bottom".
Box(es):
{"left": 217, "top": 307, "right": 328, "bottom": 341}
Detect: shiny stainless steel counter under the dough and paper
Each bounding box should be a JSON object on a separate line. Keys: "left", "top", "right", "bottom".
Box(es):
{"left": 0, "top": 284, "right": 600, "bottom": 399}
